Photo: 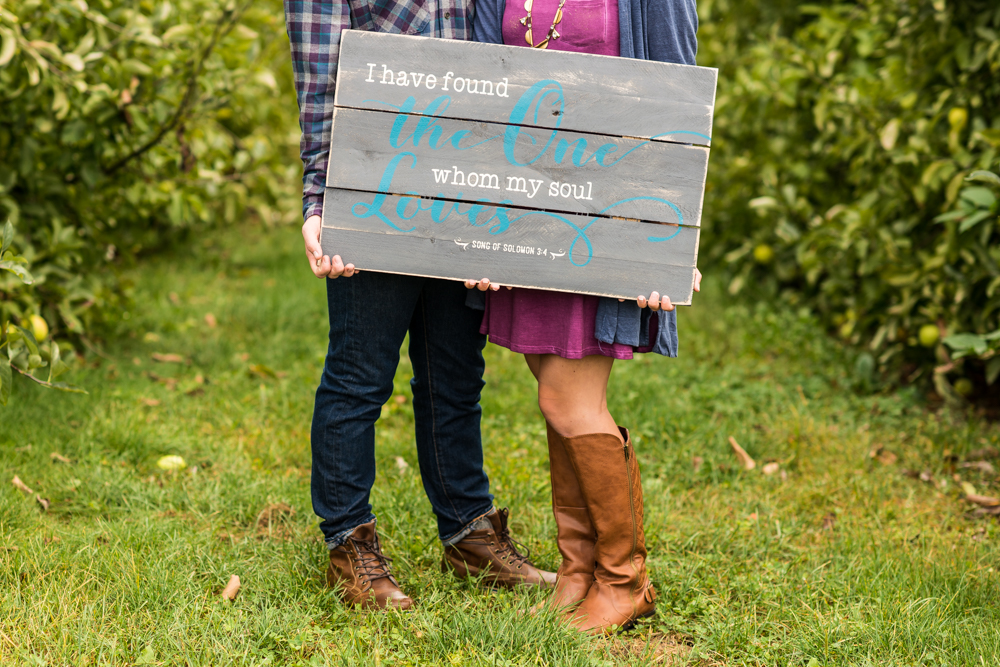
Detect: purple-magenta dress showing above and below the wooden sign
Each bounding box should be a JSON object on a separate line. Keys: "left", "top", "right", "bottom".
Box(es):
{"left": 480, "top": 0, "right": 657, "bottom": 359}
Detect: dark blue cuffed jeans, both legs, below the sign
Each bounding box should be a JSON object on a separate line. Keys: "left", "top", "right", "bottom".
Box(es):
{"left": 312, "top": 271, "right": 493, "bottom": 548}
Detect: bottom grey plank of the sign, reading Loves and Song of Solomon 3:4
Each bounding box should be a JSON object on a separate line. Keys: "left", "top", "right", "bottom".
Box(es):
{"left": 322, "top": 188, "right": 700, "bottom": 305}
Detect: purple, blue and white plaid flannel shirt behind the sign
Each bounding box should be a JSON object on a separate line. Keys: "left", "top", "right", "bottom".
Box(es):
{"left": 285, "top": 0, "right": 473, "bottom": 218}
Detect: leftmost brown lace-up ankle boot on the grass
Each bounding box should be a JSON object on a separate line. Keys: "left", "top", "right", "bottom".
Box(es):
{"left": 326, "top": 521, "right": 413, "bottom": 610}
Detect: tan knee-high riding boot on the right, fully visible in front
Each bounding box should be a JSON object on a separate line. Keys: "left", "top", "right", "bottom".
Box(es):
{"left": 563, "top": 429, "right": 656, "bottom": 634}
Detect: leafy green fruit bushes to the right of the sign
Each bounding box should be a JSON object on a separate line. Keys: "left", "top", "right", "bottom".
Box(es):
{"left": 699, "top": 0, "right": 1000, "bottom": 391}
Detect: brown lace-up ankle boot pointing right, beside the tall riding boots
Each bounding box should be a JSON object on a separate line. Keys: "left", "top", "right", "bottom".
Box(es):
{"left": 441, "top": 507, "right": 556, "bottom": 588}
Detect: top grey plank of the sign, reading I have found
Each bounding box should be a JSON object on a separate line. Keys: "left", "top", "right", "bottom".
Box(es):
{"left": 336, "top": 30, "right": 718, "bottom": 145}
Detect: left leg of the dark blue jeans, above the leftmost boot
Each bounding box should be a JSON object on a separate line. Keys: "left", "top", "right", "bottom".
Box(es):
{"left": 312, "top": 271, "right": 426, "bottom": 547}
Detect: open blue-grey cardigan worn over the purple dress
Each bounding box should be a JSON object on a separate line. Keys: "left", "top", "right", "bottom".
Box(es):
{"left": 469, "top": 0, "right": 698, "bottom": 357}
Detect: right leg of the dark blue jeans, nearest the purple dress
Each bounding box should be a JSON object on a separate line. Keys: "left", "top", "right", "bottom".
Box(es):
{"left": 409, "top": 278, "right": 493, "bottom": 541}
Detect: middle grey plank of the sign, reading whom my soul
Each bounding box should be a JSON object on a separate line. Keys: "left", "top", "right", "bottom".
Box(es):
{"left": 327, "top": 108, "right": 709, "bottom": 225}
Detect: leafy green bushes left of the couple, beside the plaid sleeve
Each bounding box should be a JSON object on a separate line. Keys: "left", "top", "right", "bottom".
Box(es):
{"left": 0, "top": 0, "right": 298, "bottom": 344}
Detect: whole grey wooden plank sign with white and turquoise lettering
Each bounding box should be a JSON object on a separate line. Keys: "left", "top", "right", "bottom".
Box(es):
{"left": 322, "top": 30, "right": 717, "bottom": 305}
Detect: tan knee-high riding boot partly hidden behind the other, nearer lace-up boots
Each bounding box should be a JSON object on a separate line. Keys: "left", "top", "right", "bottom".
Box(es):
{"left": 545, "top": 422, "right": 597, "bottom": 609}
